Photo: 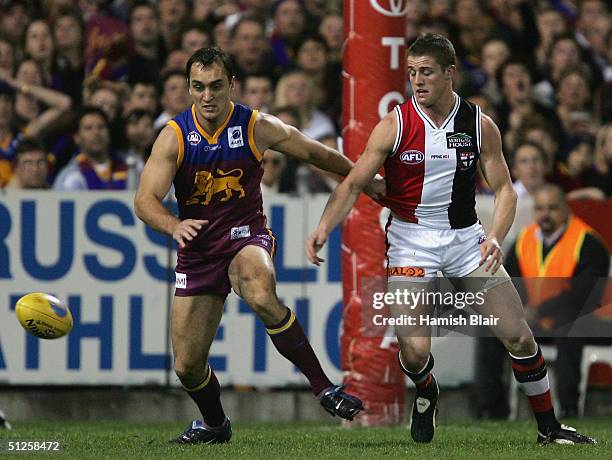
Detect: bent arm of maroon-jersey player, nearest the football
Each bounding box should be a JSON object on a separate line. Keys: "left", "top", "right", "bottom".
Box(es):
{"left": 134, "top": 126, "right": 207, "bottom": 247}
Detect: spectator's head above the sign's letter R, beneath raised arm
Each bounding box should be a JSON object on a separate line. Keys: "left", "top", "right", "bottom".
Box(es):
{"left": 7, "top": 139, "right": 49, "bottom": 189}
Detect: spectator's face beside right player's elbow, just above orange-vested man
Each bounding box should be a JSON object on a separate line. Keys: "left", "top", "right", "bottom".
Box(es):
{"left": 512, "top": 142, "right": 546, "bottom": 198}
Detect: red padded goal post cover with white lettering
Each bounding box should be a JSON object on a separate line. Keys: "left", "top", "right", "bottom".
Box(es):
{"left": 341, "top": 0, "right": 407, "bottom": 426}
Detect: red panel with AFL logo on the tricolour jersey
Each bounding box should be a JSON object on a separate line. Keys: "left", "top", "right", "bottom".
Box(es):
{"left": 385, "top": 100, "right": 425, "bottom": 223}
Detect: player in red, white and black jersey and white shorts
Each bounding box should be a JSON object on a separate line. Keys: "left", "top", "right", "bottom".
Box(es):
{"left": 306, "top": 34, "right": 595, "bottom": 444}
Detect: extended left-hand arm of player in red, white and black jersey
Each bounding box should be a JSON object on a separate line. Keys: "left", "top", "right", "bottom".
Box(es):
{"left": 306, "top": 112, "right": 397, "bottom": 265}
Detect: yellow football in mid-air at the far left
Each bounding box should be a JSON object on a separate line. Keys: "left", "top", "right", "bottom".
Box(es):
{"left": 15, "top": 292, "right": 72, "bottom": 339}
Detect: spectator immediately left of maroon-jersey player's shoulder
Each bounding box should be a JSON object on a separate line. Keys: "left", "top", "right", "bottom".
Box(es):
{"left": 119, "top": 110, "right": 156, "bottom": 190}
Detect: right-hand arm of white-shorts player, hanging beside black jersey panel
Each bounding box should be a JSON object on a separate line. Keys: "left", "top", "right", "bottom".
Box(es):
{"left": 480, "top": 114, "right": 517, "bottom": 274}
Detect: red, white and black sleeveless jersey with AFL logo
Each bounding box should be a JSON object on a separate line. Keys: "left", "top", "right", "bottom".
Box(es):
{"left": 384, "top": 93, "right": 481, "bottom": 229}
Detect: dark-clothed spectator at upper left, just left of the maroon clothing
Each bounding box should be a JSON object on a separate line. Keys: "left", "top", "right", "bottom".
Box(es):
{"left": 53, "top": 9, "right": 85, "bottom": 107}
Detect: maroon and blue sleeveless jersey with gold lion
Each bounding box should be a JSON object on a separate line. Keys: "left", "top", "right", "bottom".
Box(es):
{"left": 168, "top": 103, "right": 268, "bottom": 257}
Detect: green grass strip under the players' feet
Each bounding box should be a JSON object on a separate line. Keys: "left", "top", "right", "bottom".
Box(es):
{"left": 0, "top": 419, "right": 612, "bottom": 460}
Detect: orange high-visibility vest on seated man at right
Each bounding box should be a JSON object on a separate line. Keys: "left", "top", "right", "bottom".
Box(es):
{"left": 516, "top": 216, "right": 612, "bottom": 318}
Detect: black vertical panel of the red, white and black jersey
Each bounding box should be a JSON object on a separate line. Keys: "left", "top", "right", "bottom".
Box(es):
{"left": 448, "top": 99, "right": 480, "bottom": 228}
